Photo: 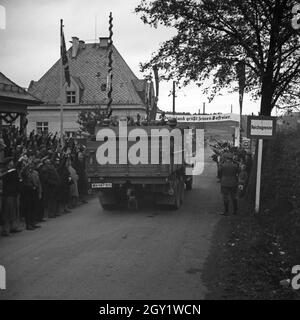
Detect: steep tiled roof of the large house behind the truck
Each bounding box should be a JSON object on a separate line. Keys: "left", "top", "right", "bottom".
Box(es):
{"left": 29, "top": 43, "right": 145, "bottom": 106}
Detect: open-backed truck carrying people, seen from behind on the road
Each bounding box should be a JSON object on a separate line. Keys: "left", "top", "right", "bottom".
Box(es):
{"left": 87, "top": 120, "right": 193, "bottom": 209}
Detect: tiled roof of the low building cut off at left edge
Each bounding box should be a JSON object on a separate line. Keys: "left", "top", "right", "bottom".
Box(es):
{"left": 0, "top": 72, "right": 42, "bottom": 104}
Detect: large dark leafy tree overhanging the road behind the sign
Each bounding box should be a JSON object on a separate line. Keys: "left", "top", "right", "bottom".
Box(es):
{"left": 135, "top": 0, "right": 300, "bottom": 115}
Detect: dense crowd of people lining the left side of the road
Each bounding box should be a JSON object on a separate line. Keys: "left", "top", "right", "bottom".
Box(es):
{"left": 0, "top": 126, "right": 88, "bottom": 236}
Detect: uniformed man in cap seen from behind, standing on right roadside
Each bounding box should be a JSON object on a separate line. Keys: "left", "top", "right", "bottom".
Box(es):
{"left": 219, "top": 152, "right": 239, "bottom": 215}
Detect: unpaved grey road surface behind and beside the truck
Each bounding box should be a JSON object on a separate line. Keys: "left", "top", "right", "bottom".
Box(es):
{"left": 0, "top": 149, "right": 221, "bottom": 300}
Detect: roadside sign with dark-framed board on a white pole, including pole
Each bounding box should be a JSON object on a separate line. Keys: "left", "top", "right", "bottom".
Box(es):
{"left": 247, "top": 116, "right": 276, "bottom": 213}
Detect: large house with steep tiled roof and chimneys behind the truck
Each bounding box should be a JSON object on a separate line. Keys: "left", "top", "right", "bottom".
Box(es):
{"left": 27, "top": 37, "right": 155, "bottom": 136}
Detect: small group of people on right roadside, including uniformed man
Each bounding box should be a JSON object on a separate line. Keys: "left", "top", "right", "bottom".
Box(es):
{"left": 211, "top": 142, "right": 252, "bottom": 215}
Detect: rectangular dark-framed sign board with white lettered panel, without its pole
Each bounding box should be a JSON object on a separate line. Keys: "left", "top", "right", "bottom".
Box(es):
{"left": 247, "top": 116, "right": 276, "bottom": 139}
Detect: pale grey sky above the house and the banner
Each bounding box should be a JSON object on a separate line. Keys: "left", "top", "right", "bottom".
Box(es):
{"left": 0, "top": 0, "right": 259, "bottom": 114}
